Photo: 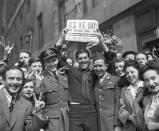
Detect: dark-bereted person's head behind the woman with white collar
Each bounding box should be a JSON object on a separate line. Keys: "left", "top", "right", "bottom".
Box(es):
{"left": 122, "top": 51, "right": 136, "bottom": 61}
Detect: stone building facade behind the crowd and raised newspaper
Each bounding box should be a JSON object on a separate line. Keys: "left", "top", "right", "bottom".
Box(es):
{"left": 4, "top": 0, "right": 159, "bottom": 63}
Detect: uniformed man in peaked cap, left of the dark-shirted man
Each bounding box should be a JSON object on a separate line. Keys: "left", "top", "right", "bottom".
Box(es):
{"left": 40, "top": 48, "right": 69, "bottom": 131}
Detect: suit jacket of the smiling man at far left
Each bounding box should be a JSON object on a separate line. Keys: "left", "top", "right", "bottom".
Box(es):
{"left": 0, "top": 89, "right": 32, "bottom": 131}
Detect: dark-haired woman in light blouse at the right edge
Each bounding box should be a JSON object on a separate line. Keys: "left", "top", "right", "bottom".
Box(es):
{"left": 142, "top": 62, "right": 159, "bottom": 131}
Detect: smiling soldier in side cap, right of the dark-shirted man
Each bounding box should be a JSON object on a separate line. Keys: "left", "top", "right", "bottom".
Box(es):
{"left": 93, "top": 52, "right": 120, "bottom": 131}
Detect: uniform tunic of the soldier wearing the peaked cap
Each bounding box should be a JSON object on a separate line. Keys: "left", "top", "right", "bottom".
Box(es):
{"left": 42, "top": 71, "right": 69, "bottom": 131}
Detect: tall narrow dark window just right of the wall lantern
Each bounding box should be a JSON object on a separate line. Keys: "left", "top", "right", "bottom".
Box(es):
{"left": 37, "top": 13, "right": 44, "bottom": 49}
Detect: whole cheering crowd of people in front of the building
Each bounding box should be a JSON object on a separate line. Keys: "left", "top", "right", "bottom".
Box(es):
{"left": 0, "top": 28, "right": 159, "bottom": 131}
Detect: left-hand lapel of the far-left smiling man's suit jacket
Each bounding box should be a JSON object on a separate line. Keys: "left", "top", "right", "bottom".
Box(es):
{"left": 0, "top": 89, "right": 10, "bottom": 124}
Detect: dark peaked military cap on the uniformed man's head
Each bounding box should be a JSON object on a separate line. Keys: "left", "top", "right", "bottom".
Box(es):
{"left": 39, "top": 48, "right": 59, "bottom": 61}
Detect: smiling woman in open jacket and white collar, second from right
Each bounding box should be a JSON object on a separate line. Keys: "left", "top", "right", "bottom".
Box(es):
{"left": 119, "top": 61, "right": 143, "bottom": 131}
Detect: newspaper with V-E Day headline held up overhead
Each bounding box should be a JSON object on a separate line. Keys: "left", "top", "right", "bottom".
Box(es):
{"left": 65, "top": 20, "right": 100, "bottom": 42}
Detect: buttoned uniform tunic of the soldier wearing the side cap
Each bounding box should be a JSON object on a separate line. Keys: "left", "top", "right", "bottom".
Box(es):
{"left": 95, "top": 74, "right": 119, "bottom": 131}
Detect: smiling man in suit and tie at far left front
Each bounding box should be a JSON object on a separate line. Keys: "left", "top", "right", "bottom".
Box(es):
{"left": 0, "top": 67, "right": 45, "bottom": 131}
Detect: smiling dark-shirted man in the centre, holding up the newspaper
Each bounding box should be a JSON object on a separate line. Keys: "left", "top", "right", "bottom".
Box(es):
{"left": 62, "top": 48, "right": 98, "bottom": 131}
